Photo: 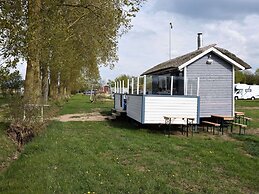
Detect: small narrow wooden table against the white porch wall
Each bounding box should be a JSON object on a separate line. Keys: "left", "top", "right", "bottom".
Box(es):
{"left": 164, "top": 116, "right": 195, "bottom": 137}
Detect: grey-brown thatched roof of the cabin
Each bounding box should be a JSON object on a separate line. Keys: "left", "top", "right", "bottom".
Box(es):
{"left": 141, "top": 44, "right": 251, "bottom": 75}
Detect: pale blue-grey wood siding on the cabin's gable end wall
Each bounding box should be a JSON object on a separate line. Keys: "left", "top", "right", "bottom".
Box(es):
{"left": 187, "top": 53, "right": 233, "bottom": 117}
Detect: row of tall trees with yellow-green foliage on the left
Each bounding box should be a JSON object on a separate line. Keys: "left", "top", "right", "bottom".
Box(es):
{"left": 0, "top": 0, "right": 144, "bottom": 103}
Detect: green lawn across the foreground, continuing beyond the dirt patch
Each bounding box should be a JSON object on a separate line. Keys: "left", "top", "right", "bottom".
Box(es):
{"left": 0, "top": 95, "right": 259, "bottom": 193}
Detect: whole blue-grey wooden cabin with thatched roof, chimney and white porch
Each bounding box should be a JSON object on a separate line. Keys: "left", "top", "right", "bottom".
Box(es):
{"left": 115, "top": 33, "right": 251, "bottom": 124}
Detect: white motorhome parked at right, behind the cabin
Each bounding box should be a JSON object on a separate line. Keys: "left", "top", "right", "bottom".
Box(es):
{"left": 234, "top": 84, "right": 259, "bottom": 100}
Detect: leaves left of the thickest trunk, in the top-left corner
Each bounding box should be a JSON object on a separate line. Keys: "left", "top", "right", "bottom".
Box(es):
{"left": 0, "top": 0, "right": 28, "bottom": 67}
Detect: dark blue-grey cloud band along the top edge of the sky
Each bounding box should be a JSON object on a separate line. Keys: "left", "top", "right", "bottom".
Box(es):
{"left": 153, "top": 0, "right": 259, "bottom": 20}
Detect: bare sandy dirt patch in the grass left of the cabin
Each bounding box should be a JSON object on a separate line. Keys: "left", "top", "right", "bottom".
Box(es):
{"left": 54, "top": 112, "right": 111, "bottom": 122}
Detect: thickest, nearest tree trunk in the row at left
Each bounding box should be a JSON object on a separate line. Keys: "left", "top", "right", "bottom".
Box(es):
{"left": 24, "top": 0, "right": 41, "bottom": 103}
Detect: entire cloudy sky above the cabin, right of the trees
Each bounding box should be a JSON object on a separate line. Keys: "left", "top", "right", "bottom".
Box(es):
{"left": 100, "top": 0, "right": 259, "bottom": 81}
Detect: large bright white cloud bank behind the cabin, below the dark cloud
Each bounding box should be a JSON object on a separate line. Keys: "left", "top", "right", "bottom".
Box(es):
{"left": 101, "top": 5, "right": 259, "bottom": 79}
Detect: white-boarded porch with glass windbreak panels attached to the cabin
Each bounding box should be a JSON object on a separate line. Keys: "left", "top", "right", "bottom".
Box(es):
{"left": 114, "top": 76, "right": 200, "bottom": 124}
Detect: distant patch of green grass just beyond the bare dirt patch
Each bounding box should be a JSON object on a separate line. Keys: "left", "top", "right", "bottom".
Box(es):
{"left": 60, "top": 94, "right": 113, "bottom": 115}
